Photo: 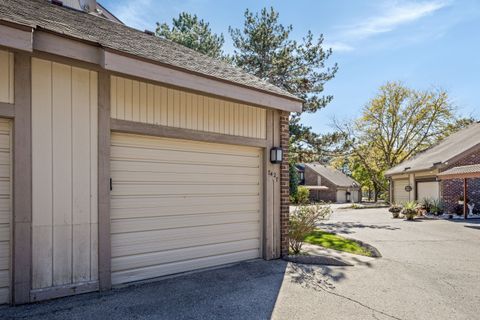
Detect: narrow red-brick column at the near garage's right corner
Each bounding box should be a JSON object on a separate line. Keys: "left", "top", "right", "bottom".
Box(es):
{"left": 280, "top": 111, "right": 290, "bottom": 257}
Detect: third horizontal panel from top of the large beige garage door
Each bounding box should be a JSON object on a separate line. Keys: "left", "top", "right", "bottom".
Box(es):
{"left": 110, "top": 159, "right": 260, "bottom": 176}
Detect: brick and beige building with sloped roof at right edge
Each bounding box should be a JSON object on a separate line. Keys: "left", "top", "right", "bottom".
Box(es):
{"left": 385, "top": 123, "right": 480, "bottom": 218}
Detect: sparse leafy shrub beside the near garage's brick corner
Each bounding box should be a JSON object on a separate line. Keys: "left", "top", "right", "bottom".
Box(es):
{"left": 288, "top": 205, "right": 332, "bottom": 254}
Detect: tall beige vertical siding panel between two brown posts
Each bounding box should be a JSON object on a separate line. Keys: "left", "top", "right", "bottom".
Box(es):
{"left": 32, "top": 58, "right": 98, "bottom": 289}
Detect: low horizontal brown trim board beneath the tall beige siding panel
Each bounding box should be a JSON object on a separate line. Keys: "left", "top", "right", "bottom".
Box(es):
{"left": 30, "top": 281, "right": 99, "bottom": 302}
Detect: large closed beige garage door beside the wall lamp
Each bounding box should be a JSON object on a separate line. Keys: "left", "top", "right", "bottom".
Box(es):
{"left": 110, "top": 133, "right": 262, "bottom": 284}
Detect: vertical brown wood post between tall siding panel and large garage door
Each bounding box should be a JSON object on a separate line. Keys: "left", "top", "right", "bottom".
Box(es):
{"left": 98, "top": 72, "right": 112, "bottom": 291}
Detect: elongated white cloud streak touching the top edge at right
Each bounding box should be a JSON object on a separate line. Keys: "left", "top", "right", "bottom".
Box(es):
{"left": 343, "top": 1, "right": 449, "bottom": 39}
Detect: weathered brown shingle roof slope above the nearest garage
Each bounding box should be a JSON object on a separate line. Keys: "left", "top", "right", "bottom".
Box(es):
{"left": 0, "top": 0, "right": 301, "bottom": 102}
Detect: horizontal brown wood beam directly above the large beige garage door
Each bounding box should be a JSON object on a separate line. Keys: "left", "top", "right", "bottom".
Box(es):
{"left": 110, "top": 119, "right": 267, "bottom": 148}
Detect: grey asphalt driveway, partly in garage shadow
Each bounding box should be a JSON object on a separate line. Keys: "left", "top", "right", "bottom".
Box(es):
{"left": 0, "top": 209, "right": 480, "bottom": 320}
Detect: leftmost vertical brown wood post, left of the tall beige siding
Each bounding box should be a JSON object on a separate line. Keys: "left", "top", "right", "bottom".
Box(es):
{"left": 12, "top": 52, "right": 32, "bottom": 304}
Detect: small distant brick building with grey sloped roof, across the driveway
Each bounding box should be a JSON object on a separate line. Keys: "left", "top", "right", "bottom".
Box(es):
{"left": 304, "top": 163, "right": 361, "bottom": 203}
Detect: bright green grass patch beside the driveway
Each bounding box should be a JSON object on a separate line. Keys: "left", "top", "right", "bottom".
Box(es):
{"left": 305, "top": 230, "right": 372, "bottom": 257}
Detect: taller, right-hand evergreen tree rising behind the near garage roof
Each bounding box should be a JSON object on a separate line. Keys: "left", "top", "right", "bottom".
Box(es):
{"left": 229, "top": 8, "right": 338, "bottom": 159}
